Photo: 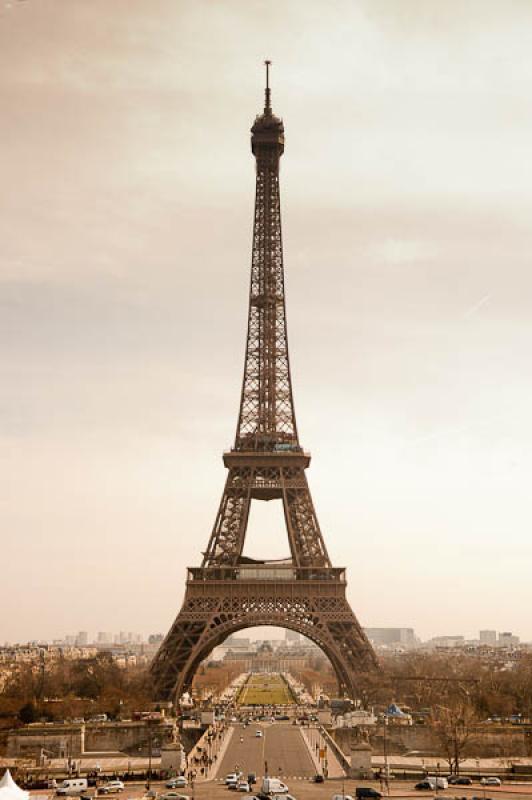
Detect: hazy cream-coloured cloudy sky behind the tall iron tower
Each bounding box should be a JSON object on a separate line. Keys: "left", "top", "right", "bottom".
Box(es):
{"left": 0, "top": 0, "right": 532, "bottom": 642}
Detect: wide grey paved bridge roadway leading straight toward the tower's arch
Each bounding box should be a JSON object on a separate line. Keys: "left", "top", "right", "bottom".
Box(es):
{"left": 218, "top": 722, "right": 316, "bottom": 778}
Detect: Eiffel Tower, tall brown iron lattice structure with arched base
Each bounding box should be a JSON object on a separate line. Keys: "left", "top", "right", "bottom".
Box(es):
{"left": 151, "top": 61, "right": 377, "bottom": 701}
